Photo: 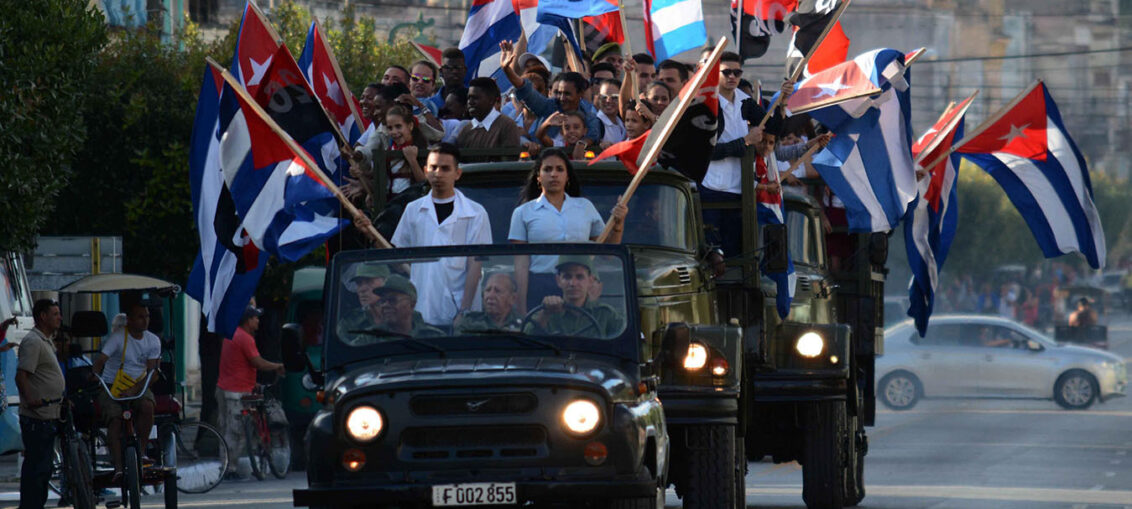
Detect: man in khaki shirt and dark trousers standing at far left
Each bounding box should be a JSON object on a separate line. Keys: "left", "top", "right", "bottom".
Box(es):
{"left": 16, "top": 299, "right": 66, "bottom": 509}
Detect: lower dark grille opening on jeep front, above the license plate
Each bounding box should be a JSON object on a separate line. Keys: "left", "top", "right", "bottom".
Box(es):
{"left": 400, "top": 425, "right": 548, "bottom": 460}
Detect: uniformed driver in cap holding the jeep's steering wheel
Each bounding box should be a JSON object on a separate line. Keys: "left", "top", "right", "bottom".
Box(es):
{"left": 524, "top": 255, "right": 625, "bottom": 338}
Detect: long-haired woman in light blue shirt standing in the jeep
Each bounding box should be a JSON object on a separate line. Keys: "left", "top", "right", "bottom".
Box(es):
{"left": 507, "top": 148, "right": 628, "bottom": 313}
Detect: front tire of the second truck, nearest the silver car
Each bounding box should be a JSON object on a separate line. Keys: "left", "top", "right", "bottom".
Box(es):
{"left": 801, "top": 400, "right": 849, "bottom": 509}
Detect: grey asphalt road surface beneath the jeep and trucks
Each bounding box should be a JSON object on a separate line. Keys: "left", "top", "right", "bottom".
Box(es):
{"left": 0, "top": 317, "right": 1132, "bottom": 509}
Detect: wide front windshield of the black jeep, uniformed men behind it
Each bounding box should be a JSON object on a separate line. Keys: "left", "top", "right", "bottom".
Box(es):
{"left": 331, "top": 250, "right": 629, "bottom": 353}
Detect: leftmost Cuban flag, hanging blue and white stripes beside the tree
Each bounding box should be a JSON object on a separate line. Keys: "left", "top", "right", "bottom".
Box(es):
{"left": 186, "top": 66, "right": 267, "bottom": 337}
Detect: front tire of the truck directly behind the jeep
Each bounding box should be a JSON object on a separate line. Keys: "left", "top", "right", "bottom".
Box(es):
{"left": 684, "top": 425, "right": 743, "bottom": 509}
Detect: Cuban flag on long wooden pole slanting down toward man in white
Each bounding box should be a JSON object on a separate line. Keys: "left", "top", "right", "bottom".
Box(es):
{"left": 217, "top": 65, "right": 340, "bottom": 261}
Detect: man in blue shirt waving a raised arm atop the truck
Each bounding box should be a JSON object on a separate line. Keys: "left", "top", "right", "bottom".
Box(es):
{"left": 499, "top": 41, "right": 602, "bottom": 145}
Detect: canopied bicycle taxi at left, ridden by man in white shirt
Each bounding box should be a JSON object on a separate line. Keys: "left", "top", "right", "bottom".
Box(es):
{"left": 52, "top": 274, "right": 229, "bottom": 509}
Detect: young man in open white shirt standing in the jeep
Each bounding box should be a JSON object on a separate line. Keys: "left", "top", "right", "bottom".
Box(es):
{"left": 391, "top": 143, "right": 491, "bottom": 326}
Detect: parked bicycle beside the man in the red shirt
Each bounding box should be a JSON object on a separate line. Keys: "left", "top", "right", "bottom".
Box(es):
{"left": 240, "top": 383, "right": 291, "bottom": 481}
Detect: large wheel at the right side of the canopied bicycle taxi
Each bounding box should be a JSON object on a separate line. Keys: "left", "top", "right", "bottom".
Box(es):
{"left": 173, "top": 422, "right": 229, "bottom": 493}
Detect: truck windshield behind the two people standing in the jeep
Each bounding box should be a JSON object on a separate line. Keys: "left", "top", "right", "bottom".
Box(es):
{"left": 460, "top": 182, "right": 695, "bottom": 250}
